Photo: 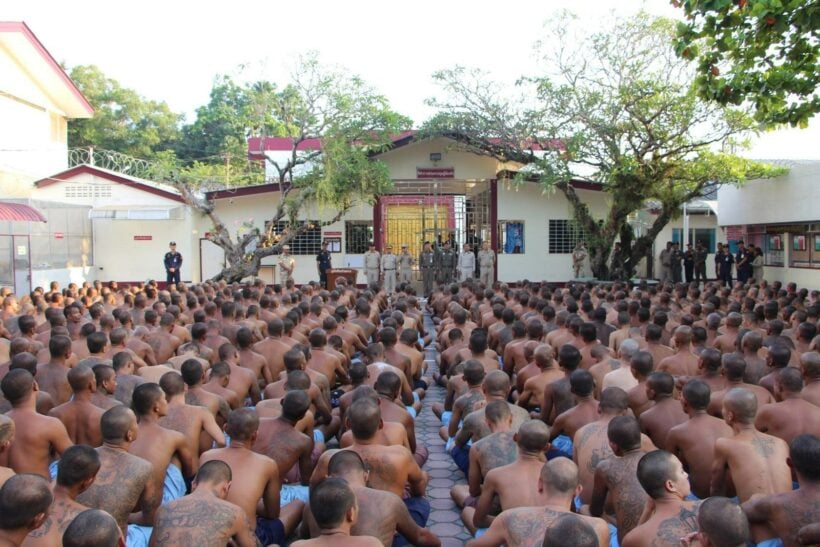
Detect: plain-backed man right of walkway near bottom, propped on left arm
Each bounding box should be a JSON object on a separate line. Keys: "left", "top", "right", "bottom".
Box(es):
{"left": 461, "top": 420, "right": 549, "bottom": 535}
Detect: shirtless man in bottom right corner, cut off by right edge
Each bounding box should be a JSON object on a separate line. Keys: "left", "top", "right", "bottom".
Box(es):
{"left": 742, "top": 434, "right": 820, "bottom": 547}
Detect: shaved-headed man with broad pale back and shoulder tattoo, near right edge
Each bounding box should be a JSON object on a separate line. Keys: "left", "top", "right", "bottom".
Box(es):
{"left": 710, "top": 388, "right": 792, "bottom": 503}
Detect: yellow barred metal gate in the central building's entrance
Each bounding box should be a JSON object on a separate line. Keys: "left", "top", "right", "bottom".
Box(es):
{"left": 378, "top": 180, "right": 493, "bottom": 268}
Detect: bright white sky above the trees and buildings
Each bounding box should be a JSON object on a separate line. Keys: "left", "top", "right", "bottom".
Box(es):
{"left": 6, "top": 0, "right": 820, "bottom": 159}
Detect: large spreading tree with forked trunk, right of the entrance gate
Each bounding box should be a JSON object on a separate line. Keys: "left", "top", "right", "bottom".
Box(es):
{"left": 424, "top": 13, "right": 780, "bottom": 279}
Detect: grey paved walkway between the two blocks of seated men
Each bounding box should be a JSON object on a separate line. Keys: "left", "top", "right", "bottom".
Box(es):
{"left": 416, "top": 315, "right": 471, "bottom": 547}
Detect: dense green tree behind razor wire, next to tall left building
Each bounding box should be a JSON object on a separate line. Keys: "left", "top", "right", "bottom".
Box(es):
{"left": 68, "top": 65, "right": 181, "bottom": 159}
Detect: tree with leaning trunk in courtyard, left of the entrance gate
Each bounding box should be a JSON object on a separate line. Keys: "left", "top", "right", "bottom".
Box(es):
{"left": 154, "top": 55, "right": 411, "bottom": 282}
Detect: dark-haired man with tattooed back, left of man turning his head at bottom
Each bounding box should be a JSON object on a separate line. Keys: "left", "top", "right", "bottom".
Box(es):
{"left": 581, "top": 416, "right": 647, "bottom": 541}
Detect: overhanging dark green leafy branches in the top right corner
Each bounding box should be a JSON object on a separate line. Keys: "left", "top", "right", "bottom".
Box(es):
{"left": 672, "top": 0, "right": 820, "bottom": 127}
